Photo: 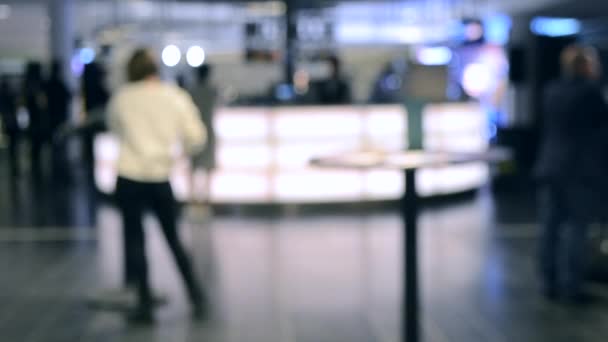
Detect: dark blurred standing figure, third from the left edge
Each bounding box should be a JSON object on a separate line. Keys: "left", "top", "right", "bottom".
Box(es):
{"left": 46, "top": 60, "right": 72, "bottom": 181}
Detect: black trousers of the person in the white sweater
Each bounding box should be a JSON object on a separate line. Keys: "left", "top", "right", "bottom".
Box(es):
{"left": 116, "top": 177, "right": 203, "bottom": 310}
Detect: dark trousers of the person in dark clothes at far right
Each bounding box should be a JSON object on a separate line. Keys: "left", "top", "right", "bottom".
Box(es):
{"left": 539, "top": 184, "right": 588, "bottom": 299}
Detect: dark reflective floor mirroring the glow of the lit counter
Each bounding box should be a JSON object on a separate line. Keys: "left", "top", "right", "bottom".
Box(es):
{"left": 0, "top": 156, "right": 608, "bottom": 342}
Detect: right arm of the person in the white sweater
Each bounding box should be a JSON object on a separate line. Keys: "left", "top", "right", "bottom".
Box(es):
{"left": 180, "top": 93, "right": 207, "bottom": 155}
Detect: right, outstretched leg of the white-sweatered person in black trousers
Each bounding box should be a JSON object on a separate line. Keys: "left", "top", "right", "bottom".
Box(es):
{"left": 152, "top": 182, "right": 205, "bottom": 314}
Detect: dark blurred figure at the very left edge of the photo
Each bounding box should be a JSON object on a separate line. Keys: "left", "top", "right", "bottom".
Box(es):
{"left": 0, "top": 76, "right": 21, "bottom": 178}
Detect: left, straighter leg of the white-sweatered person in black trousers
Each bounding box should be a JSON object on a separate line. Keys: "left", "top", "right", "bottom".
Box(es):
{"left": 116, "top": 178, "right": 152, "bottom": 320}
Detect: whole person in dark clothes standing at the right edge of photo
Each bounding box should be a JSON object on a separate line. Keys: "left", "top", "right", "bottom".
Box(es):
{"left": 535, "top": 45, "right": 608, "bottom": 302}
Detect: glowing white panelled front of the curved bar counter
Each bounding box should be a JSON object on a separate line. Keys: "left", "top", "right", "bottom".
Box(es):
{"left": 95, "top": 103, "right": 489, "bottom": 204}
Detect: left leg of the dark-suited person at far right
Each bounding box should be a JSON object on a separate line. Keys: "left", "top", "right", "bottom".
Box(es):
{"left": 539, "top": 186, "right": 563, "bottom": 298}
